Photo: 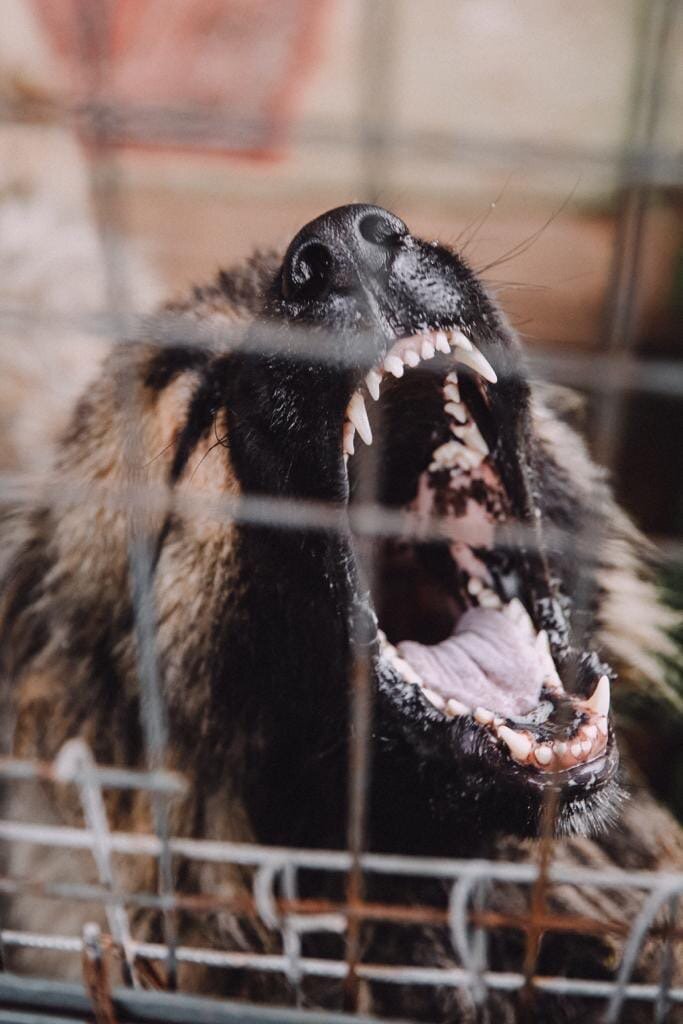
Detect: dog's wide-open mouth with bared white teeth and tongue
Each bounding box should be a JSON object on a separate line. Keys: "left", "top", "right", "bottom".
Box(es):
{"left": 342, "top": 327, "right": 616, "bottom": 793}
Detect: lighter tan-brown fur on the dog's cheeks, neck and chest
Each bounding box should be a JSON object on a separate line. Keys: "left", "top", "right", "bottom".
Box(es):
{"left": 0, "top": 264, "right": 683, "bottom": 1021}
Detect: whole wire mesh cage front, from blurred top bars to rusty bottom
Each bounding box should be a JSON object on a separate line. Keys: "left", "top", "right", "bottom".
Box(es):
{"left": 0, "top": 0, "right": 683, "bottom": 1024}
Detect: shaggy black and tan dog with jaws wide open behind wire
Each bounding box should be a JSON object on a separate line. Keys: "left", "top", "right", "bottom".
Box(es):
{"left": 1, "top": 205, "right": 680, "bottom": 1020}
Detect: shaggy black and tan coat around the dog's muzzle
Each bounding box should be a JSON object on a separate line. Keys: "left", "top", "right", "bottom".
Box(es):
{"left": 0, "top": 203, "right": 683, "bottom": 1022}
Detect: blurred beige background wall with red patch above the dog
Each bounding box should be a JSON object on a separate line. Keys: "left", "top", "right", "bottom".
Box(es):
{"left": 0, "top": 0, "right": 683, "bottom": 535}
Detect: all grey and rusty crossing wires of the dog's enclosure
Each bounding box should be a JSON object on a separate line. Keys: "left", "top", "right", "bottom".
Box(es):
{"left": 0, "top": 0, "right": 683, "bottom": 1024}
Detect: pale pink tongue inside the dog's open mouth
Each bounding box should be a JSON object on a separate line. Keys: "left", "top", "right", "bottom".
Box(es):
{"left": 398, "top": 608, "right": 544, "bottom": 716}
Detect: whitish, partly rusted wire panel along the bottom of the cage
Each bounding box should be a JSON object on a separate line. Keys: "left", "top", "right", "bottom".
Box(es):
{"left": 0, "top": 739, "right": 683, "bottom": 1022}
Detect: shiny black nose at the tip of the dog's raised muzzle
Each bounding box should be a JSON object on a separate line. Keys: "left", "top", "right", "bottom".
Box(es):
{"left": 283, "top": 203, "right": 408, "bottom": 302}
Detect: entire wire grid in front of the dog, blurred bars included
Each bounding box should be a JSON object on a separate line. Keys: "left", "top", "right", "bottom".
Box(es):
{"left": 0, "top": 2, "right": 683, "bottom": 1022}
